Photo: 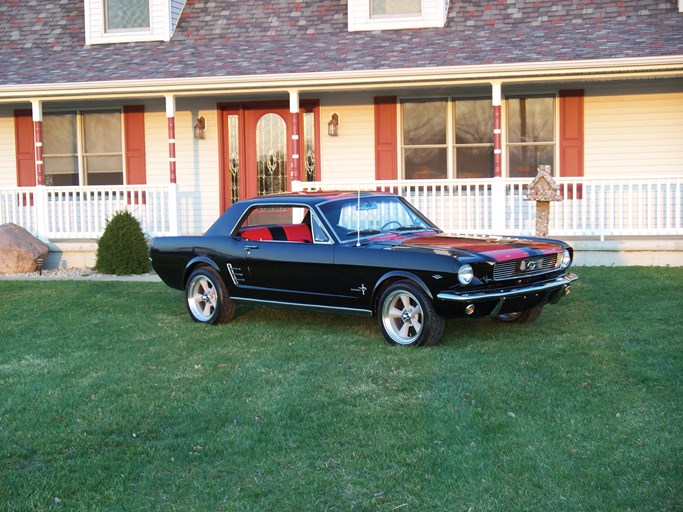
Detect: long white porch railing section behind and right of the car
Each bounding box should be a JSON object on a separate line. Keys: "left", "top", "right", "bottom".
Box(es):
{"left": 301, "top": 176, "right": 683, "bottom": 239}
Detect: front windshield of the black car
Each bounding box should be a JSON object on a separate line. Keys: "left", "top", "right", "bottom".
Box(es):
{"left": 320, "top": 196, "right": 436, "bottom": 241}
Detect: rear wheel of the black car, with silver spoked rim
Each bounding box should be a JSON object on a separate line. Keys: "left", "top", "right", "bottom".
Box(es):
{"left": 185, "top": 267, "right": 236, "bottom": 324}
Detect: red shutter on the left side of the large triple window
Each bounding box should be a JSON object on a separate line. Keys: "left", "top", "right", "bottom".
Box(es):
{"left": 375, "top": 96, "right": 398, "bottom": 180}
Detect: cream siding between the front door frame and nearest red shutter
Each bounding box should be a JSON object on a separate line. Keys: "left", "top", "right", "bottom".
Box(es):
{"left": 320, "top": 93, "right": 375, "bottom": 181}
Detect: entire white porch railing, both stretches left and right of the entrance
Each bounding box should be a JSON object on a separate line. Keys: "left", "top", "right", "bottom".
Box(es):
{"left": 0, "top": 176, "right": 683, "bottom": 240}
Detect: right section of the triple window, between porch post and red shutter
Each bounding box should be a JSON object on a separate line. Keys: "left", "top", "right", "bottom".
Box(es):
{"left": 507, "top": 96, "right": 555, "bottom": 178}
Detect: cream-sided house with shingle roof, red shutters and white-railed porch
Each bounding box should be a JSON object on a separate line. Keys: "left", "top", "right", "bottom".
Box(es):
{"left": 0, "top": 0, "right": 683, "bottom": 265}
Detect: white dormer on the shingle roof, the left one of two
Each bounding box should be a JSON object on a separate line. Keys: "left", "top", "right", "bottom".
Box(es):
{"left": 85, "top": 0, "right": 186, "bottom": 44}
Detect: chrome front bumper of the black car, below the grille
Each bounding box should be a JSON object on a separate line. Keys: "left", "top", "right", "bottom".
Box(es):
{"left": 437, "top": 273, "right": 579, "bottom": 316}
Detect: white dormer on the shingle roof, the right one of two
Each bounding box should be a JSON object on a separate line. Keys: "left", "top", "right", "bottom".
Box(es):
{"left": 348, "top": 0, "right": 449, "bottom": 32}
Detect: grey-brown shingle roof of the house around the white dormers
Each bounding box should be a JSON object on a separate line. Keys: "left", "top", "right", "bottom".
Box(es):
{"left": 0, "top": 0, "right": 683, "bottom": 85}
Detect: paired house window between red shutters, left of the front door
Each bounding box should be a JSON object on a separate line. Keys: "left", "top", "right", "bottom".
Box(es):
{"left": 43, "top": 110, "right": 123, "bottom": 186}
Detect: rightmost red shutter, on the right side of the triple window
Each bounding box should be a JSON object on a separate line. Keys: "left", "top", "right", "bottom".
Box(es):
{"left": 560, "top": 89, "right": 583, "bottom": 199}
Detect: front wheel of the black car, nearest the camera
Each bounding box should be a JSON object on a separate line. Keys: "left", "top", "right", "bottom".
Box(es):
{"left": 377, "top": 281, "right": 445, "bottom": 346}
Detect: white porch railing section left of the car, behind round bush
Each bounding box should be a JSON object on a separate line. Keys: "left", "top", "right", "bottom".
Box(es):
{"left": 0, "top": 185, "right": 178, "bottom": 240}
